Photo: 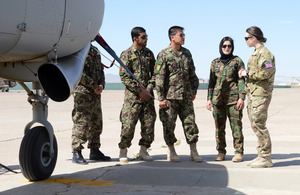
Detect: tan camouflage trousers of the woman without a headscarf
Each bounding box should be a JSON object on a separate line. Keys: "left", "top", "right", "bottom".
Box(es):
{"left": 247, "top": 94, "right": 272, "bottom": 157}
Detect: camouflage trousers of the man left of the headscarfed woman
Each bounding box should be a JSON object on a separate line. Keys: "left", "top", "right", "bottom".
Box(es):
{"left": 159, "top": 99, "right": 199, "bottom": 146}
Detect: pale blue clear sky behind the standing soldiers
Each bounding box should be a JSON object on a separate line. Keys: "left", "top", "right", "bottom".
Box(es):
{"left": 99, "top": 0, "right": 300, "bottom": 82}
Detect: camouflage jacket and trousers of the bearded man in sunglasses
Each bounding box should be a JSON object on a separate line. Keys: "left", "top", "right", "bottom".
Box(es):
{"left": 119, "top": 45, "right": 156, "bottom": 149}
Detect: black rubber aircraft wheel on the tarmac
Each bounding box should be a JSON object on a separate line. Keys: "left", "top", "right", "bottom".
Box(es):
{"left": 19, "top": 126, "right": 57, "bottom": 181}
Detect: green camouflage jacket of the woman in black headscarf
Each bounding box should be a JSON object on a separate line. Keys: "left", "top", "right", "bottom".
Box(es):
{"left": 207, "top": 56, "right": 245, "bottom": 105}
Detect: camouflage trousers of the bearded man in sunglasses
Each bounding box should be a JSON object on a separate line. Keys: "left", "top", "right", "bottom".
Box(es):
{"left": 119, "top": 99, "right": 156, "bottom": 148}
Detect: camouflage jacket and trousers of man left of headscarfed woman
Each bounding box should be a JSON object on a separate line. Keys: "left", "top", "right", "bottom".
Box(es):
{"left": 155, "top": 45, "right": 199, "bottom": 146}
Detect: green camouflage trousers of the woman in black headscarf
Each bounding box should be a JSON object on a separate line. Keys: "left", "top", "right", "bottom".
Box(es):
{"left": 213, "top": 104, "right": 244, "bottom": 154}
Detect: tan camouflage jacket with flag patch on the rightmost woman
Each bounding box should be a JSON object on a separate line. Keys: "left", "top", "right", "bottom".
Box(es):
{"left": 246, "top": 45, "right": 276, "bottom": 96}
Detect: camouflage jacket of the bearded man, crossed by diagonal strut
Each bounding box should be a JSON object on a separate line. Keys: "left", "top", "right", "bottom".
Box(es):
{"left": 119, "top": 45, "right": 155, "bottom": 99}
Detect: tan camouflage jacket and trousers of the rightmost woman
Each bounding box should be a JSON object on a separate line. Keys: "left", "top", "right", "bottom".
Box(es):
{"left": 246, "top": 45, "right": 275, "bottom": 157}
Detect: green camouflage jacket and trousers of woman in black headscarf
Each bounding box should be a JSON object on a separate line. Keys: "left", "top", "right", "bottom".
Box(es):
{"left": 207, "top": 56, "right": 245, "bottom": 154}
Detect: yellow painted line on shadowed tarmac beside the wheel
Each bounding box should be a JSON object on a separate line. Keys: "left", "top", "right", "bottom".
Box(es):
{"left": 22, "top": 178, "right": 117, "bottom": 187}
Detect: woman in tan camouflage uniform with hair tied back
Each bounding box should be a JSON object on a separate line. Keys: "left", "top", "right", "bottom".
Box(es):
{"left": 239, "top": 26, "right": 276, "bottom": 168}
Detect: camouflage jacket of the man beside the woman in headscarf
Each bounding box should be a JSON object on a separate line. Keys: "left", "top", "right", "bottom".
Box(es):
{"left": 154, "top": 45, "right": 199, "bottom": 101}
